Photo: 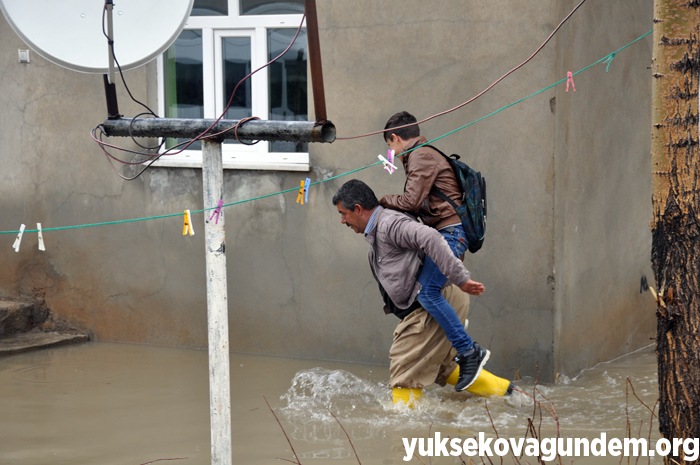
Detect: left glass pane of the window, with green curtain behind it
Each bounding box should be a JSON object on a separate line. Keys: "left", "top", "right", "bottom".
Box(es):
{"left": 164, "top": 30, "right": 204, "bottom": 150}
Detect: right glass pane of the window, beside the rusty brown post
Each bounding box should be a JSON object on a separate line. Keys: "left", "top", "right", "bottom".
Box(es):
{"left": 268, "top": 29, "right": 308, "bottom": 152}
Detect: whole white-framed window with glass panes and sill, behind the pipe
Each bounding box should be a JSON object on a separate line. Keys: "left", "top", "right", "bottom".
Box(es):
{"left": 154, "top": 0, "right": 309, "bottom": 171}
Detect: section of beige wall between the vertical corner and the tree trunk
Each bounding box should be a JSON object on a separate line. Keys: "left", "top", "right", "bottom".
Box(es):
{"left": 554, "top": 1, "right": 655, "bottom": 373}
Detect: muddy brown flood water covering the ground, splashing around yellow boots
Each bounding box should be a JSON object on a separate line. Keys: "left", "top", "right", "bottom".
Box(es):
{"left": 0, "top": 342, "right": 661, "bottom": 465}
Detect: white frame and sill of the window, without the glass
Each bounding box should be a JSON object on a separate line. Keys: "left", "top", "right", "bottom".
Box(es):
{"left": 153, "top": 6, "right": 311, "bottom": 171}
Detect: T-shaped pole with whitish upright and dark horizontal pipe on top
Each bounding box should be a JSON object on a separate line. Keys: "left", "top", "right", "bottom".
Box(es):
{"left": 103, "top": 118, "right": 335, "bottom": 465}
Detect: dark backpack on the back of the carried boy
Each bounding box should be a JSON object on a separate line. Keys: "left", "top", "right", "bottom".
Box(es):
{"left": 425, "top": 145, "right": 486, "bottom": 253}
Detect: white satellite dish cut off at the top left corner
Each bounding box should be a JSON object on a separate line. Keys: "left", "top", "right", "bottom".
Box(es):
{"left": 0, "top": 0, "right": 194, "bottom": 74}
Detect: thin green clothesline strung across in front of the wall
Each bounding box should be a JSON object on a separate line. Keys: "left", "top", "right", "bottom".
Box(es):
{"left": 0, "top": 30, "right": 653, "bottom": 234}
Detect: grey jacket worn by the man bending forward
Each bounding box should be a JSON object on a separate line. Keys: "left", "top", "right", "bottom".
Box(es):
{"left": 365, "top": 206, "right": 470, "bottom": 313}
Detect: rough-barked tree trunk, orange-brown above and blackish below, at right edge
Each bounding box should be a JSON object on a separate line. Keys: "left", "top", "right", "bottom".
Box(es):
{"left": 651, "top": 0, "right": 700, "bottom": 463}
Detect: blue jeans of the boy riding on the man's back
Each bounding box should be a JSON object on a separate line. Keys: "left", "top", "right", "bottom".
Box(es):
{"left": 416, "top": 225, "right": 474, "bottom": 354}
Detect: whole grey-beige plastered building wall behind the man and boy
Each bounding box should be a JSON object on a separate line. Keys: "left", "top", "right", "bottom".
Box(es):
{"left": 0, "top": 0, "right": 653, "bottom": 379}
